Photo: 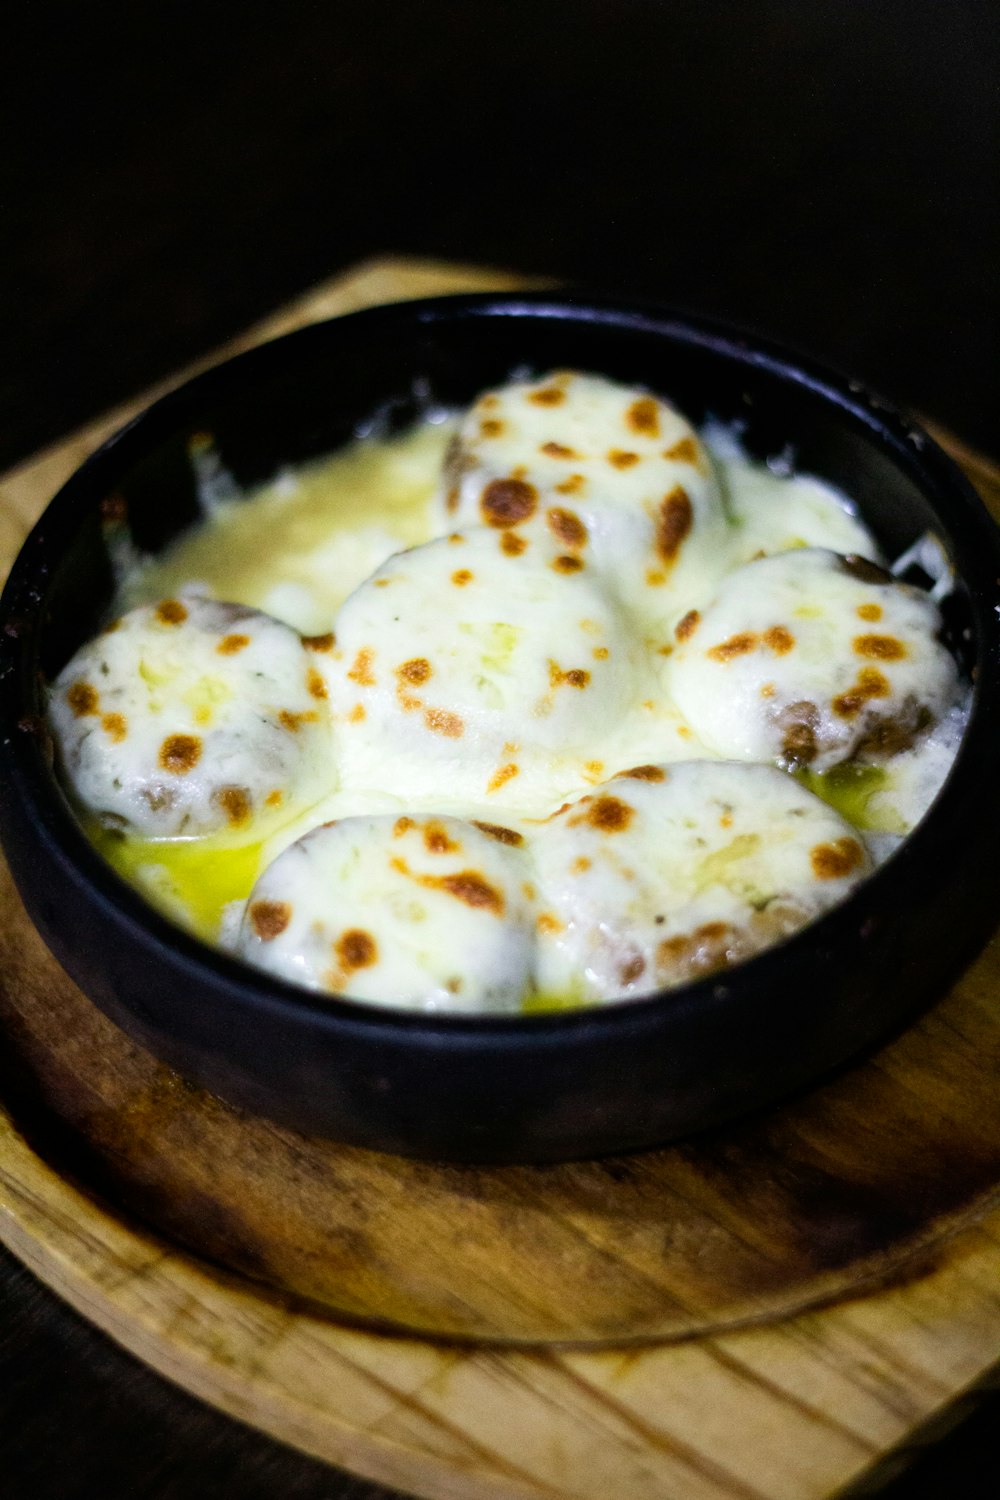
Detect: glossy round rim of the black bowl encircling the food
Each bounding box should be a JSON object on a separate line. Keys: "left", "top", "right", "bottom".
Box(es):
{"left": 0, "top": 291, "right": 1000, "bottom": 1050}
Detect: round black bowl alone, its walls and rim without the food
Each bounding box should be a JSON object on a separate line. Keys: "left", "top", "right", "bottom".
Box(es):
{"left": 0, "top": 296, "right": 1000, "bottom": 1161}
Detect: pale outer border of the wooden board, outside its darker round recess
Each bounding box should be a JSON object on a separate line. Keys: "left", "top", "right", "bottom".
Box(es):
{"left": 0, "top": 257, "right": 1000, "bottom": 1500}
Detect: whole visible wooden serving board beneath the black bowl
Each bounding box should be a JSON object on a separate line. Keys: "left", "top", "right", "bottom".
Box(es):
{"left": 0, "top": 261, "right": 1000, "bottom": 1500}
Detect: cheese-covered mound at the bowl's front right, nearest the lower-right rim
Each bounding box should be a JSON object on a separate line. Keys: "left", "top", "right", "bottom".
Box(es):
{"left": 532, "top": 761, "right": 871, "bottom": 1001}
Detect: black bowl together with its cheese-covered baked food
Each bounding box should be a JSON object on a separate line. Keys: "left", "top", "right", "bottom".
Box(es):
{"left": 0, "top": 296, "right": 1000, "bottom": 1161}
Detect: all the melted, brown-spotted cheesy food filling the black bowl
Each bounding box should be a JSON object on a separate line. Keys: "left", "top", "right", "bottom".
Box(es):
{"left": 52, "top": 372, "right": 964, "bottom": 1010}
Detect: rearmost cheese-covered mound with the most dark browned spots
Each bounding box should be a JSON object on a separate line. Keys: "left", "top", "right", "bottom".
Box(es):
{"left": 444, "top": 371, "right": 727, "bottom": 617}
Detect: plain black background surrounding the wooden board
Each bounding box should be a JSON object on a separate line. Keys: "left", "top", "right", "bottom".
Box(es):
{"left": 0, "top": 0, "right": 1000, "bottom": 1500}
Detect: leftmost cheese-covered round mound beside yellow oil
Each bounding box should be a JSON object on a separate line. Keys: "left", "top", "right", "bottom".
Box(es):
{"left": 49, "top": 597, "right": 334, "bottom": 839}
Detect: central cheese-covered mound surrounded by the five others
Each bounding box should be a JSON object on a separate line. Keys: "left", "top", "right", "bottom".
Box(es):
{"left": 331, "top": 528, "right": 642, "bottom": 804}
